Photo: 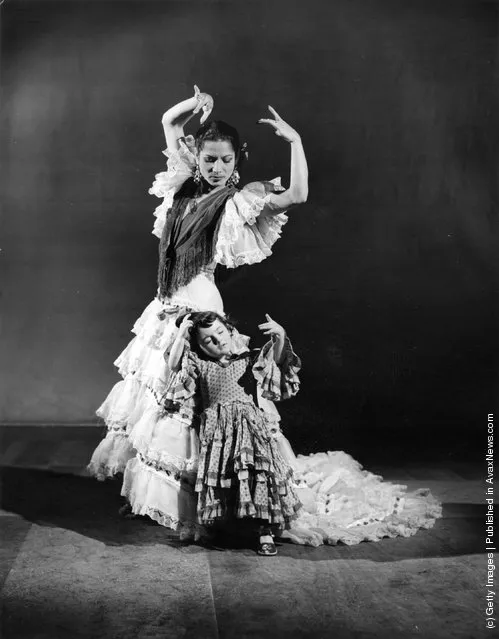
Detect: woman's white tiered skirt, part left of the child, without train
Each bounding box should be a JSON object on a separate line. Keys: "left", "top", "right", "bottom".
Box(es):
{"left": 88, "top": 275, "right": 223, "bottom": 538}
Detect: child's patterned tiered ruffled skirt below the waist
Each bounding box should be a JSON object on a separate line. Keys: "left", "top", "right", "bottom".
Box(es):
{"left": 195, "top": 402, "right": 301, "bottom": 528}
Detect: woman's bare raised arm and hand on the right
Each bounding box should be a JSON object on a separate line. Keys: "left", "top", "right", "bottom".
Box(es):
{"left": 258, "top": 106, "right": 308, "bottom": 215}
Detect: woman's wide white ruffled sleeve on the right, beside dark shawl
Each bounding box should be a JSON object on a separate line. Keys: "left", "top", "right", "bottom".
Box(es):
{"left": 215, "top": 178, "right": 288, "bottom": 268}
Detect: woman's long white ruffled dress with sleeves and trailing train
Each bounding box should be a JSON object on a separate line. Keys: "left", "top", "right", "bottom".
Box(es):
{"left": 88, "top": 141, "right": 441, "bottom": 546}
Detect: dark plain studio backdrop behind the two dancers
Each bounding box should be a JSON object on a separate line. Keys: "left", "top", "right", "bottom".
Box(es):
{"left": 0, "top": 0, "right": 498, "bottom": 452}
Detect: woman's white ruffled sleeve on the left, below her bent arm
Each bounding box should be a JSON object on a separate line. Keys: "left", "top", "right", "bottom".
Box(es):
{"left": 149, "top": 136, "right": 196, "bottom": 238}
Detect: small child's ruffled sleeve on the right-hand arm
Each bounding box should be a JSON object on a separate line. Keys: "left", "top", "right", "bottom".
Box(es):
{"left": 253, "top": 337, "right": 301, "bottom": 402}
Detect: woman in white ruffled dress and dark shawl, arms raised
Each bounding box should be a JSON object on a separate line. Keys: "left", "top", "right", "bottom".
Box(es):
{"left": 89, "top": 87, "right": 440, "bottom": 546}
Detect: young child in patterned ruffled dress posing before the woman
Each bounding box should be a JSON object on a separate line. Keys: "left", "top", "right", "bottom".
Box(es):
{"left": 162, "top": 312, "right": 300, "bottom": 556}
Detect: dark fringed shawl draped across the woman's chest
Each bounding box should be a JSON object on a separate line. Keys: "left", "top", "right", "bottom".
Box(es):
{"left": 158, "top": 178, "right": 237, "bottom": 297}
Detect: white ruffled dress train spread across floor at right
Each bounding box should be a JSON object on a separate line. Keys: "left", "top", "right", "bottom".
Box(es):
{"left": 283, "top": 451, "right": 442, "bottom": 546}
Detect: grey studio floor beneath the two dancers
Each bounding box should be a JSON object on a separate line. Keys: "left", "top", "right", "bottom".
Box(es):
{"left": 0, "top": 427, "right": 492, "bottom": 639}
